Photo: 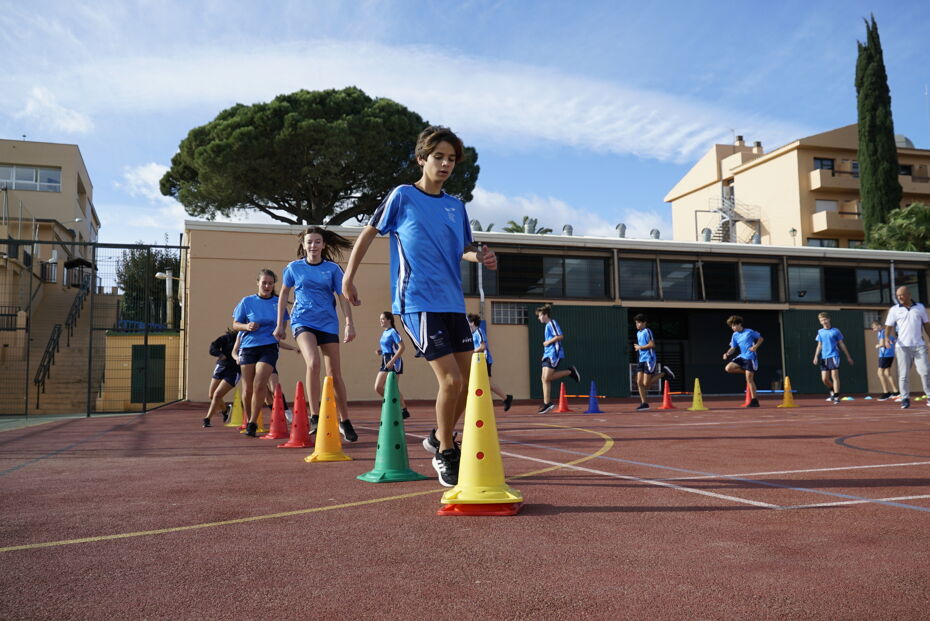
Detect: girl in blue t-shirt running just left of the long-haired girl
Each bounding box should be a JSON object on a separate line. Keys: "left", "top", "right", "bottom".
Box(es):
{"left": 233, "top": 269, "right": 286, "bottom": 437}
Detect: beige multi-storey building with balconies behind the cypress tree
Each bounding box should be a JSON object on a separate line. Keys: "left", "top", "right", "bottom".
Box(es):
{"left": 665, "top": 124, "right": 930, "bottom": 248}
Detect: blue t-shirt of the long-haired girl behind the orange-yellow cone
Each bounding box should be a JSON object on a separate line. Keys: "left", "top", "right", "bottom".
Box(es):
{"left": 284, "top": 259, "right": 342, "bottom": 334}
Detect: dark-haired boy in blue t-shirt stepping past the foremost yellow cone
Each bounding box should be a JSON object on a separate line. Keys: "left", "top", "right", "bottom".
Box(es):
{"left": 342, "top": 126, "right": 497, "bottom": 487}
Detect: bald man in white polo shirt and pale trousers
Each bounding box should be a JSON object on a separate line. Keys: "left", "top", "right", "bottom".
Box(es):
{"left": 883, "top": 287, "right": 930, "bottom": 409}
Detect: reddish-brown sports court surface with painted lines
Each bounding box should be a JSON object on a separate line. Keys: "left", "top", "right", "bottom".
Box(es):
{"left": 0, "top": 398, "right": 930, "bottom": 621}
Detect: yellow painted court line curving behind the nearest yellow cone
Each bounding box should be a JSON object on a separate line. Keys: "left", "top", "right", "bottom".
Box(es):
{"left": 0, "top": 423, "right": 614, "bottom": 553}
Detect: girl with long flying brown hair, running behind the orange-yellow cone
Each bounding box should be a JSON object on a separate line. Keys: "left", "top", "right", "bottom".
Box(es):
{"left": 274, "top": 226, "right": 358, "bottom": 442}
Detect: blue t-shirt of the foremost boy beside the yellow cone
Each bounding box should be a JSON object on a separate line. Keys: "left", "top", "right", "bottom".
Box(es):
{"left": 368, "top": 185, "right": 472, "bottom": 314}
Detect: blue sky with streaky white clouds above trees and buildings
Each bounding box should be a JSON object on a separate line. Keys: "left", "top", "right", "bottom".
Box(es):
{"left": 0, "top": 0, "right": 930, "bottom": 242}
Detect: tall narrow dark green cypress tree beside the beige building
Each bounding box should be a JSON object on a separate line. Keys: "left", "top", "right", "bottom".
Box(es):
{"left": 856, "top": 15, "right": 902, "bottom": 243}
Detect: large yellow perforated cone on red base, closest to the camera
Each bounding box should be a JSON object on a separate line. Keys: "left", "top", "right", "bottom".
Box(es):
{"left": 439, "top": 353, "right": 523, "bottom": 515}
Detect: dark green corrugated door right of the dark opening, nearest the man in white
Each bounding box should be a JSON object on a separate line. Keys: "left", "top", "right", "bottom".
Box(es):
{"left": 782, "top": 310, "right": 869, "bottom": 394}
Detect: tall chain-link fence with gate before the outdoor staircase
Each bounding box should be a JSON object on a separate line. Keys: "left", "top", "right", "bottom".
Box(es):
{"left": 0, "top": 239, "right": 186, "bottom": 416}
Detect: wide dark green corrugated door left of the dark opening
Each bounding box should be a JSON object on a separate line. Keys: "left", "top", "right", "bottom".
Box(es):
{"left": 527, "top": 304, "right": 630, "bottom": 399}
